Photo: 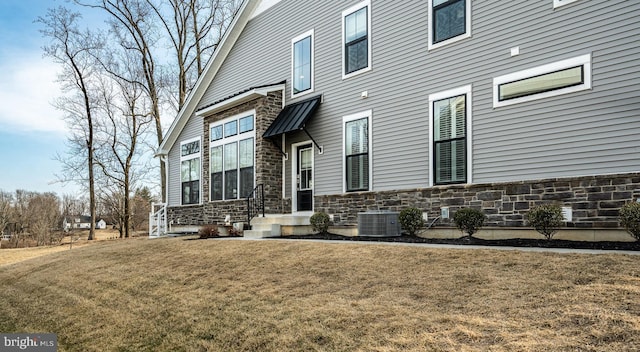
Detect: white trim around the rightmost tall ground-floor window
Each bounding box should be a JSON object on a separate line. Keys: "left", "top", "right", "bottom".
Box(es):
{"left": 429, "top": 85, "right": 473, "bottom": 187}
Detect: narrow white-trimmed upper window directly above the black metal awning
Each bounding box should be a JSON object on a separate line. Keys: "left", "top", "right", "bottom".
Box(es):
{"left": 291, "top": 30, "right": 314, "bottom": 97}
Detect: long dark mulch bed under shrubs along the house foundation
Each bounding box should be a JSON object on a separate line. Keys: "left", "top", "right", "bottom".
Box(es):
{"left": 280, "top": 233, "right": 640, "bottom": 251}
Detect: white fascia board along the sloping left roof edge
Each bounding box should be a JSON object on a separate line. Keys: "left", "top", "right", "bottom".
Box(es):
{"left": 156, "top": 0, "right": 260, "bottom": 155}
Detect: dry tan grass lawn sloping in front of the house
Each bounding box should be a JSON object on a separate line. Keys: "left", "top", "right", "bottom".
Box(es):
{"left": 0, "top": 239, "right": 640, "bottom": 351}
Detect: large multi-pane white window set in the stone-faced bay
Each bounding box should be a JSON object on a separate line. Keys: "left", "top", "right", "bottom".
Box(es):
{"left": 209, "top": 112, "right": 255, "bottom": 201}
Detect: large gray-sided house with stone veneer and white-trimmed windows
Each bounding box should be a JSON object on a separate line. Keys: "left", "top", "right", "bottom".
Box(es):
{"left": 158, "top": 0, "right": 640, "bottom": 238}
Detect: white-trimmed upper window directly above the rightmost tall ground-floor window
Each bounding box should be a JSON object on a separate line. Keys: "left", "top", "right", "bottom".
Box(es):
{"left": 427, "top": 0, "right": 471, "bottom": 49}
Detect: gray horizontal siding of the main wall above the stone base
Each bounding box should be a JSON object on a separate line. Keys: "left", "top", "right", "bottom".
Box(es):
{"left": 191, "top": 0, "right": 640, "bottom": 198}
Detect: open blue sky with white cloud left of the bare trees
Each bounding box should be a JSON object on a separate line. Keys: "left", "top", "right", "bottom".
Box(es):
{"left": 0, "top": 0, "right": 103, "bottom": 196}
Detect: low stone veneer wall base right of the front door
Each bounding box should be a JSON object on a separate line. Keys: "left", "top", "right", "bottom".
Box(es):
{"left": 315, "top": 173, "right": 640, "bottom": 228}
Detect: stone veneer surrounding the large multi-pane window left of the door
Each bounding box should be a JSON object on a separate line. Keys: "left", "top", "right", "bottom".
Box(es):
{"left": 167, "top": 91, "right": 291, "bottom": 225}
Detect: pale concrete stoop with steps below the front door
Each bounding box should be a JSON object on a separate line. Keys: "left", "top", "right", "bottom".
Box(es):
{"left": 243, "top": 214, "right": 311, "bottom": 238}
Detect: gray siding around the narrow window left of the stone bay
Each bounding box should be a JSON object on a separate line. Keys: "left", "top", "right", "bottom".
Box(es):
{"left": 167, "top": 116, "right": 202, "bottom": 206}
